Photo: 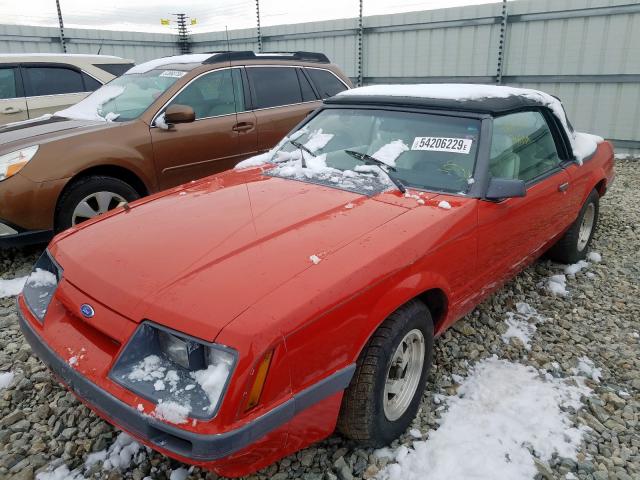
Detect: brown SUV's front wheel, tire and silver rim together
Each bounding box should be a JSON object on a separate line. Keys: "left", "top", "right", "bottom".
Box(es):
{"left": 55, "top": 176, "right": 140, "bottom": 232}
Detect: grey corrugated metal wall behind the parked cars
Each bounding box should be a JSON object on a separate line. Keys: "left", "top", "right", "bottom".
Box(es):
{"left": 0, "top": 0, "right": 640, "bottom": 149}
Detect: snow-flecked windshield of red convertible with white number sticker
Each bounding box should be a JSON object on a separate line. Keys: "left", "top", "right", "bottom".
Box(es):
{"left": 269, "top": 108, "right": 480, "bottom": 194}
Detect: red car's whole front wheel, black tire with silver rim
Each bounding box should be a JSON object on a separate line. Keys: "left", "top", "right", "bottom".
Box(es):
{"left": 338, "top": 300, "right": 433, "bottom": 448}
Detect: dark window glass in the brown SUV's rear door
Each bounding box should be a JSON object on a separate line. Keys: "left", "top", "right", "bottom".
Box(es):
{"left": 247, "top": 67, "right": 302, "bottom": 108}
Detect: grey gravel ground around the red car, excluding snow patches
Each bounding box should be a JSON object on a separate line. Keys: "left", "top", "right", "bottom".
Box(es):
{"left": 0, "top": 161, "right": 640, "bottom": 480}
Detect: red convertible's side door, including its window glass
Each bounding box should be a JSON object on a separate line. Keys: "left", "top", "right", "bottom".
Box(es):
{"left": 478, "top": 110, "right": 569, "bottom": 296}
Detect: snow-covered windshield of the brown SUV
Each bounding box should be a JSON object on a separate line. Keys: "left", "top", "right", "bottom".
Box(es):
{"left": 56, "top": 69, "right": 185, "bottom": 122}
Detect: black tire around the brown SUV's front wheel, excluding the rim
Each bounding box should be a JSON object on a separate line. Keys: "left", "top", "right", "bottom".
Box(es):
{"left": 55, "top": 176, "right": 140, "bottom": 232}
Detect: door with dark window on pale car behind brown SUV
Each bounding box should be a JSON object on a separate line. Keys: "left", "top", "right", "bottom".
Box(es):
{"left": 21, "top": 64, "right": 101, "bottom": 118}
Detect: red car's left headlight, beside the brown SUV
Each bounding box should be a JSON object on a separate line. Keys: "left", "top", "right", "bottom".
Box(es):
{"left": 22, "top": 250, "right": 62, "bottom": 323}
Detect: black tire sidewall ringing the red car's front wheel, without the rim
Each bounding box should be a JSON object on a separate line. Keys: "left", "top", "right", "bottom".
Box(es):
{"left": 371, "top": 305, "right": 433, "bottom": 446}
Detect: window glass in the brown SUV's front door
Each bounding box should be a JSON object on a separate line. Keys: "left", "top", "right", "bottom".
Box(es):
{"left": 170, "top": 68, "right": 245, "bottom": 120}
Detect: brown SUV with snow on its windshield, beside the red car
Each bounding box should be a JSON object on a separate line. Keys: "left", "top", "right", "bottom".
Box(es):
{"left": 0, "top": 52, "right": 351, "bottom": 246}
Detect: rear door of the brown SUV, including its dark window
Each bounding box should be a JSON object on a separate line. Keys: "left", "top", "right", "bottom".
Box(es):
{"left": 246, "top": 65, "right": 320, "bottom": 151}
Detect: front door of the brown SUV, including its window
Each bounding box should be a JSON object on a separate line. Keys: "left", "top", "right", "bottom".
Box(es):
{"left": 151, "top": 67, "right": 257, "bottom": 189}
